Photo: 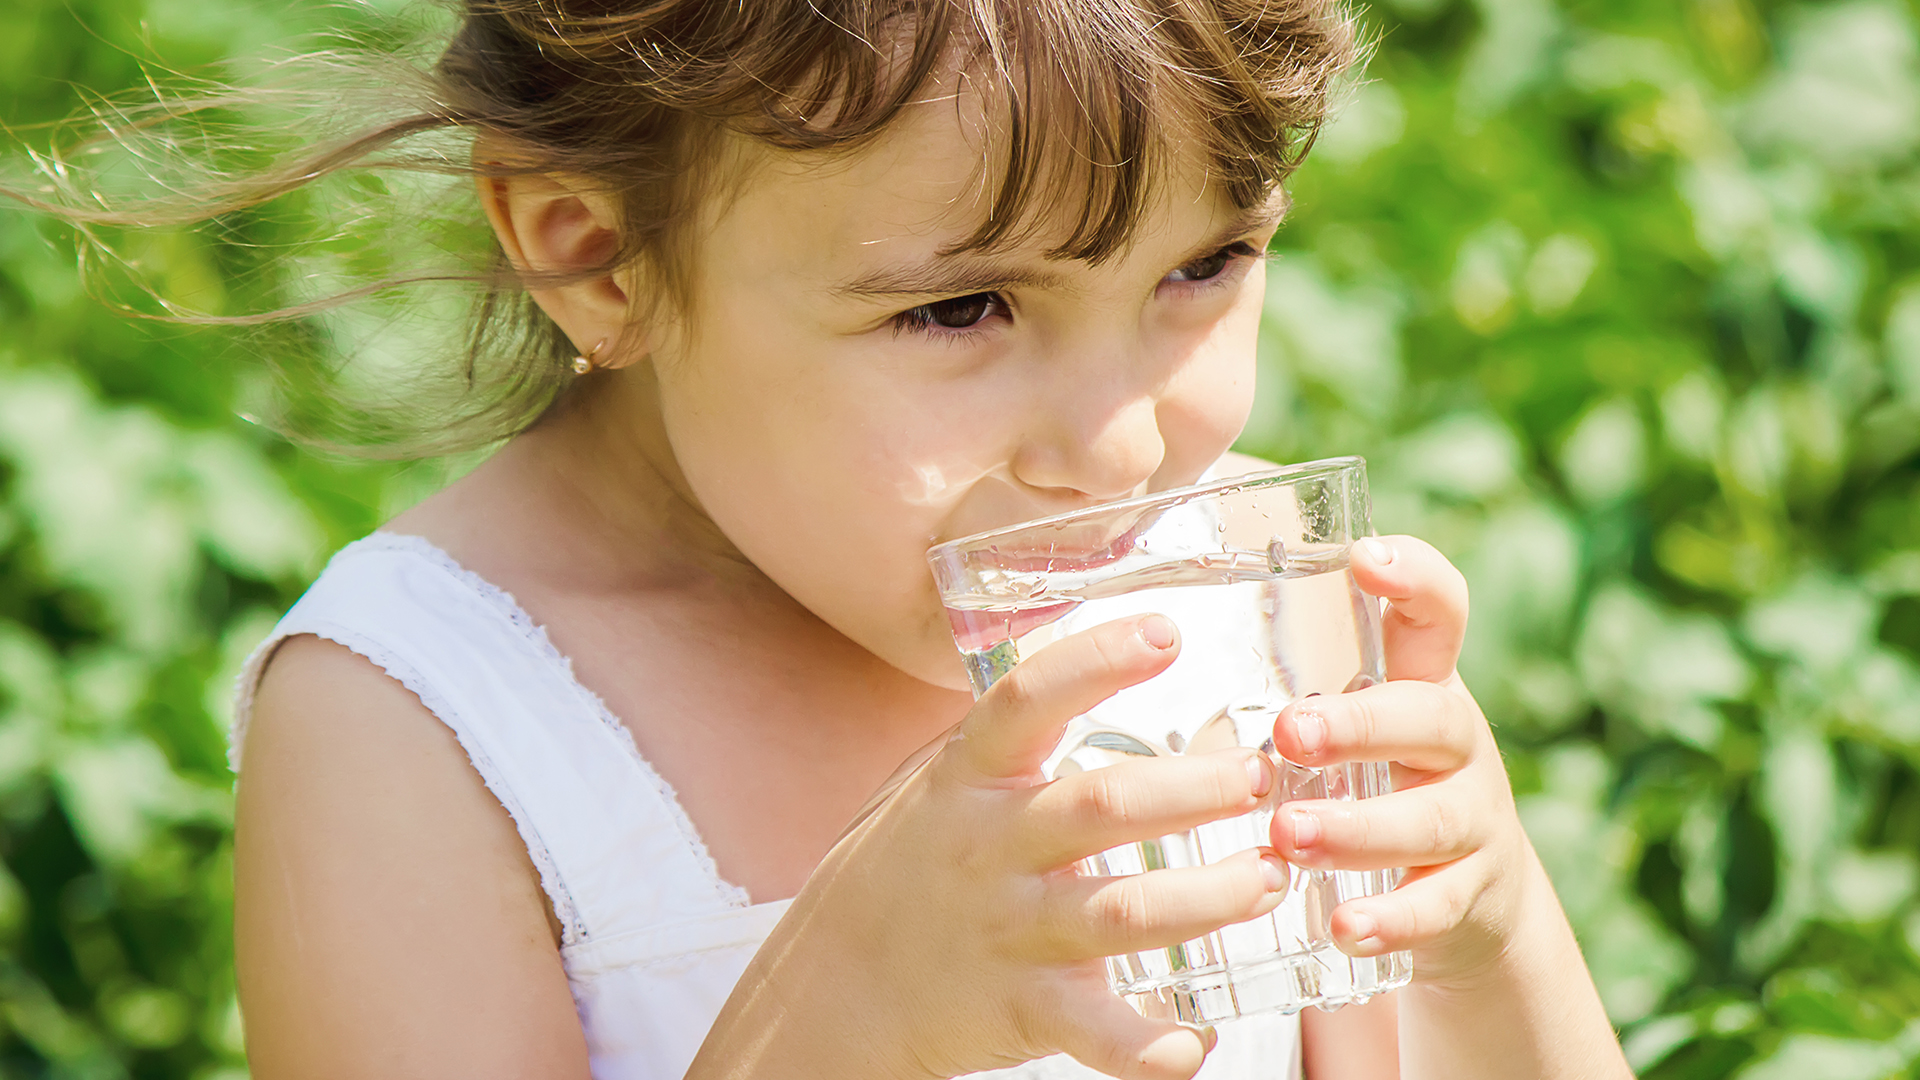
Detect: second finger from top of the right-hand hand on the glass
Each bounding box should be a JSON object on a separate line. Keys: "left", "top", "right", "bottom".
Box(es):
{"left": 1273, "top": 680, "right": 1486, "bottom": 773}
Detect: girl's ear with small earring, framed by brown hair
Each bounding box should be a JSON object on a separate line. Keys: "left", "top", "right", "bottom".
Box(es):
{"left": 478, "top": 173, "right": 647, "bottom": 367}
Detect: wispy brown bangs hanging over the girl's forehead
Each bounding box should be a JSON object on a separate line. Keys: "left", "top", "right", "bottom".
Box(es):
{"left": 929, "top": 0, "right": 1352, "bottom": 263}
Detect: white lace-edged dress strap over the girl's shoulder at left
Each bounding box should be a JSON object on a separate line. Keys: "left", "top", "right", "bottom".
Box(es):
{"left": 230, "top": 532, "right": 747, "bottom": 945}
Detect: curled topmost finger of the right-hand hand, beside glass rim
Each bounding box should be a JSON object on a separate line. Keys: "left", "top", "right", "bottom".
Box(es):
{"left": 1352, "top": 536, "right": 1467, "bottom": 682}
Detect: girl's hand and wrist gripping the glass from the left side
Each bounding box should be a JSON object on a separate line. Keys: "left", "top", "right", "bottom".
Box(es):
{"left": 687, "top": 615, "right": 1286, "bottom": 1080}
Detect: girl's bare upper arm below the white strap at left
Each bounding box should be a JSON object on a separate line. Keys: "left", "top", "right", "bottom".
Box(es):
{"left": 234, "top": 636, "right": 588, "bottom": 1080}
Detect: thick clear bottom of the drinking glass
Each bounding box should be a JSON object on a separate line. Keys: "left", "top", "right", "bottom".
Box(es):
{"left": 1123, "top": 945, "right": 1413, "bottom": 1024}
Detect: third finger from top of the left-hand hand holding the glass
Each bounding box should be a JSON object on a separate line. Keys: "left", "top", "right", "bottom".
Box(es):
{"left": 1037, "top": 849, "right": 1288, "bottom": 959}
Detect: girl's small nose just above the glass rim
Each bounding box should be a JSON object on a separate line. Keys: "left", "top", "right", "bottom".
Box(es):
{"left": 1012, "top": 354, "right": 1167, "bottom": 502}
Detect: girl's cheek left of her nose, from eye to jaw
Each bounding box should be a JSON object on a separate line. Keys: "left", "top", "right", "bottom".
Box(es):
{"left": 660, "top": 338, "right": 991, "bottom": 686}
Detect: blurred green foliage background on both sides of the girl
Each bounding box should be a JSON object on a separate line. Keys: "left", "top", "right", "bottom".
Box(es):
{"left": 0, "top": 0, "right": 1920, "bottom": 1080}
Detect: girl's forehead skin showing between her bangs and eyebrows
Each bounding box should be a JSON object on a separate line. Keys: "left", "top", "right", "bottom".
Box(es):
{"left": 708, "top": 75, "right": 1277, "bottom": 281}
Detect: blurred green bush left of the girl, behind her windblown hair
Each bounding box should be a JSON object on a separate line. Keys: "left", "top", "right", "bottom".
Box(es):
{"left": 0, "top": 0, "right": 445, "bottom": 1080}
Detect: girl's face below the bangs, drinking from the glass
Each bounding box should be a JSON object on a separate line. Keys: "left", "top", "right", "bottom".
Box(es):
{"left": 637, "top": 98, "right": 1277, "bottom": 688}
